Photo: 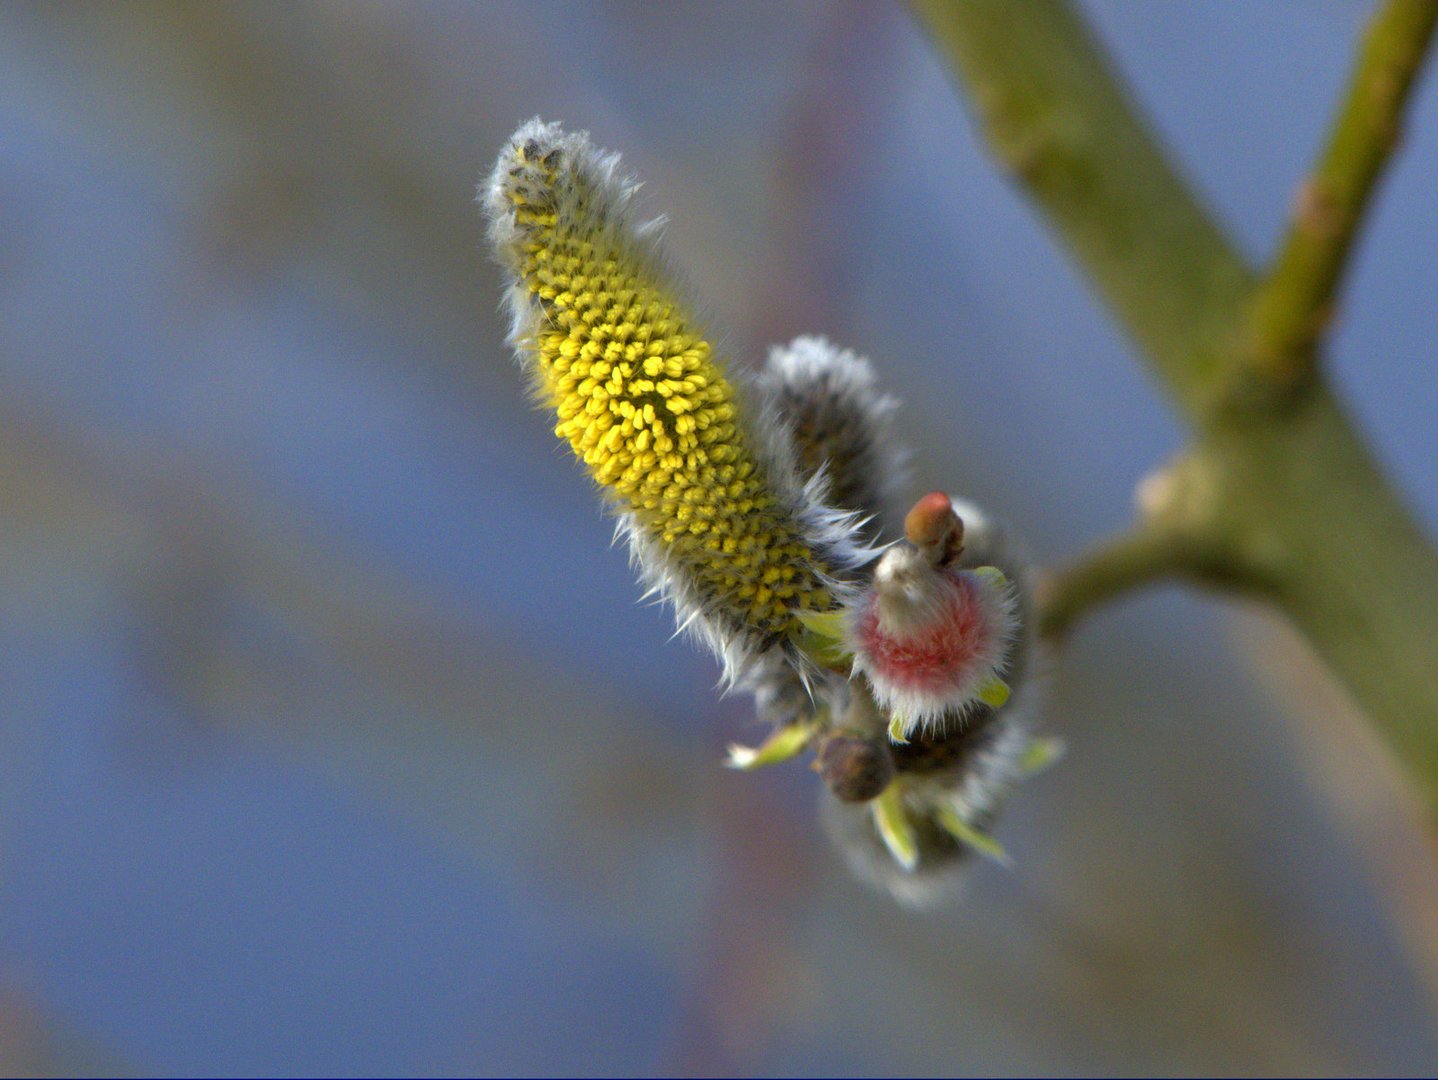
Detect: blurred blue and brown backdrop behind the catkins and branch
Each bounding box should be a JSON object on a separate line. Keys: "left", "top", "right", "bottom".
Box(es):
{"left": 0, "top": 0, "right": 1438, "bottom": 1076}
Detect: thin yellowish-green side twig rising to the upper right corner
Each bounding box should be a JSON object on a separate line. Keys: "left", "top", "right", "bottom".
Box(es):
{"left": 1248, "top": 0, "right": 1438, "bottom": 387}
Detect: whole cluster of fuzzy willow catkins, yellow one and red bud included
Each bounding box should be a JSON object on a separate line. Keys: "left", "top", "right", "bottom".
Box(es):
{"left": 480, "top": 119, "right": 1053, "bottom": 900}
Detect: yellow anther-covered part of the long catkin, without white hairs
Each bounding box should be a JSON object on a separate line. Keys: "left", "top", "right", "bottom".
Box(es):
{"left": 505, "top": 138, "right": 833, "bottom": 639}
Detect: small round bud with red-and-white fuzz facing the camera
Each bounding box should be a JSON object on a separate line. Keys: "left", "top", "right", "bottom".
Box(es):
{"left": 850, "top": 542, "right": 1018, "bottom": 738}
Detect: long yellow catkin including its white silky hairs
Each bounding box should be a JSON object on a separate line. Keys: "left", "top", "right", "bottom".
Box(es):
{"left": 480, "top": 119, "right": 870, "bottom": 683}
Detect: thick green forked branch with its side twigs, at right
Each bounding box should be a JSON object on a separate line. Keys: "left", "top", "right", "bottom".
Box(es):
{"left": 915, "top": 0, "right": 1438, "bottom": 813}
